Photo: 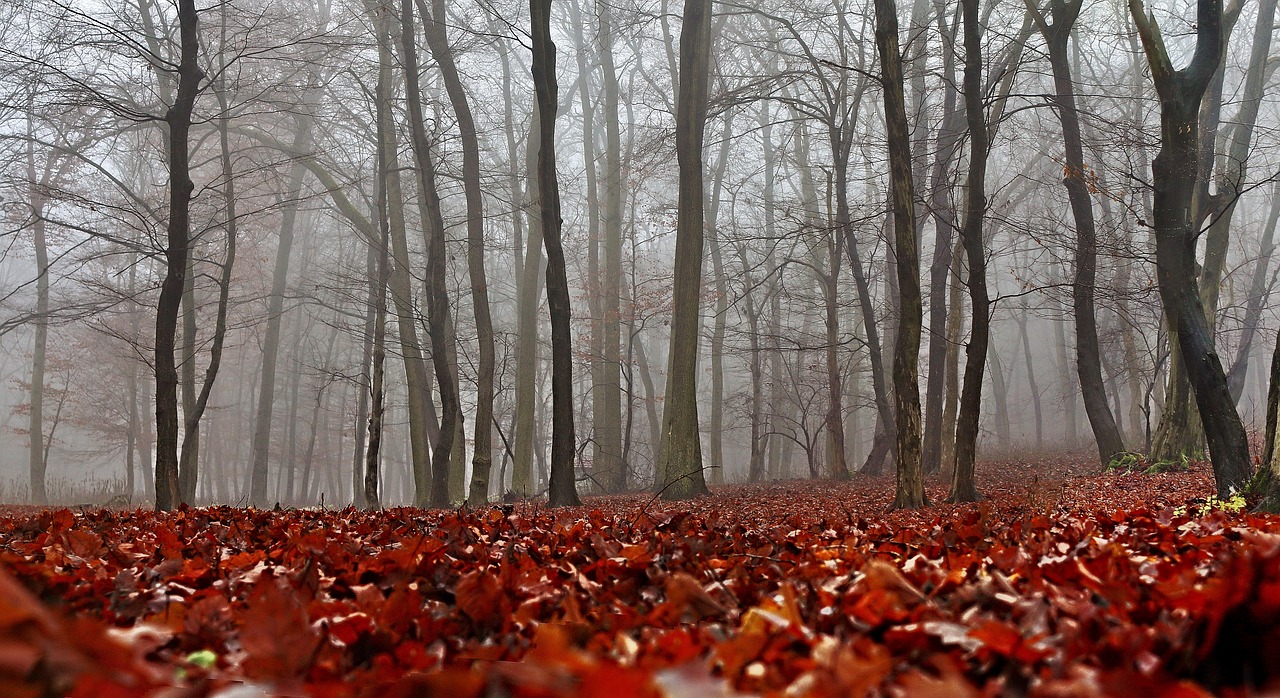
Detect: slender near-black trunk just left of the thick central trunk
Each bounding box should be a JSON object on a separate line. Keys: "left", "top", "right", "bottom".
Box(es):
{"left": 529, "top": 0, "right": 579, "bottom": 506}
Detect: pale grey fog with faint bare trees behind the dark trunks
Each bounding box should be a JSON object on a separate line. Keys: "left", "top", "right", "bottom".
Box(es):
{"left": 0, "top": 0, "right": 1280, "bottom": 506}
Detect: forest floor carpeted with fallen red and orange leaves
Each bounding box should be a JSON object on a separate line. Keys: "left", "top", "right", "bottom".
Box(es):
{"left": 0, "top": 459, "right": 1280, "bottom": 698}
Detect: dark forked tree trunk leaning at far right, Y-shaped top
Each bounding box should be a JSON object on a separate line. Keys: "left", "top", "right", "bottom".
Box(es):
{"left": 1129, "top": 0, "right": 1251, "bottom": 497}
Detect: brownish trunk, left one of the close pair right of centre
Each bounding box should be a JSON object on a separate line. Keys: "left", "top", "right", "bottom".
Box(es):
{"left": 876, "top": 0, "right": 929, "bottom": 508}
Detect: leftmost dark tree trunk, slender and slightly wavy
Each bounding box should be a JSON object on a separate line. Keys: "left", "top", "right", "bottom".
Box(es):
{"left": 155, "top": 0, "right": 205, "bottom": 511}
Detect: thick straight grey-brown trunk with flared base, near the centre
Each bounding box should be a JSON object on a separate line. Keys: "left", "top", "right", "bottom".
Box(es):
{"left": 657, "top": 0, "right": 712, "bottom": 499}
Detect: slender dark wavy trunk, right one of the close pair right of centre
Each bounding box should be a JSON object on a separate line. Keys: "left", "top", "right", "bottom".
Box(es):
{"left": 947, "top": 0, "right": 991, "bottom": 502}
